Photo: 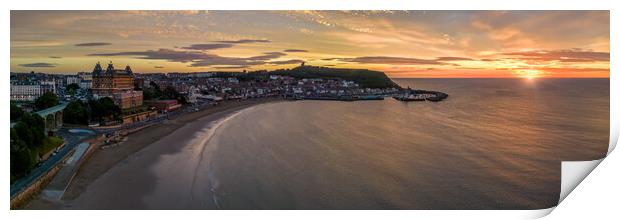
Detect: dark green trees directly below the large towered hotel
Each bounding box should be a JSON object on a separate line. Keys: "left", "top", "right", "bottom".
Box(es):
{"left": 63, "top": 97, "right": 121, "bottom": 125}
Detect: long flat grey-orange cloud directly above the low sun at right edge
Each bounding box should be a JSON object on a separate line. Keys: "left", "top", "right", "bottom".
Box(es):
{"left": 502, "top": 48, "right": 609, "bottom": 62}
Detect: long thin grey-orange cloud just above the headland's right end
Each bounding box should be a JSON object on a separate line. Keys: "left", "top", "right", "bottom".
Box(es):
{"left": 334, "top": 56, "right": 448, "bottom": 65}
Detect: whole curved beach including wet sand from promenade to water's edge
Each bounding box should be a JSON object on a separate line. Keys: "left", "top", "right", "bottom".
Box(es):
{"left": 26, "top": 98, "right": 283, "bottom": 209}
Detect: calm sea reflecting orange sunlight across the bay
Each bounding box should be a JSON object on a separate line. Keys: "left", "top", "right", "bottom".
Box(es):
{"left": 70, "top": 79, "right": 610, "bottom": 210}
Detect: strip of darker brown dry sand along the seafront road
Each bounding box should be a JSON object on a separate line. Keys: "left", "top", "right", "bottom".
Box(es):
{"left": 26, "top": 98, "right": 283, "bottom": 209}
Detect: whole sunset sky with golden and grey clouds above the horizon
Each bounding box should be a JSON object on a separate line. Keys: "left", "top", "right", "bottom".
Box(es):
{"left": 10, "top": 11, "right": 610, "bottom": 78}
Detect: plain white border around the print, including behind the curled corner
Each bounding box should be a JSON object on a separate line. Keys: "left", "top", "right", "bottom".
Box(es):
{"left": 0, "top": 0, "right": 620, "bottom": 219}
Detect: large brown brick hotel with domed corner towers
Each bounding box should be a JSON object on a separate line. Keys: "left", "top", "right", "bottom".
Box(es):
{"left": 92, "top": 62, "right": 143, "bottom": 109}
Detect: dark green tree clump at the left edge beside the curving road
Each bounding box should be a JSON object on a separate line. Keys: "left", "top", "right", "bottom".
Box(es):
{"left": 11, "top": 103, "right": 62, "bottom": 182}
